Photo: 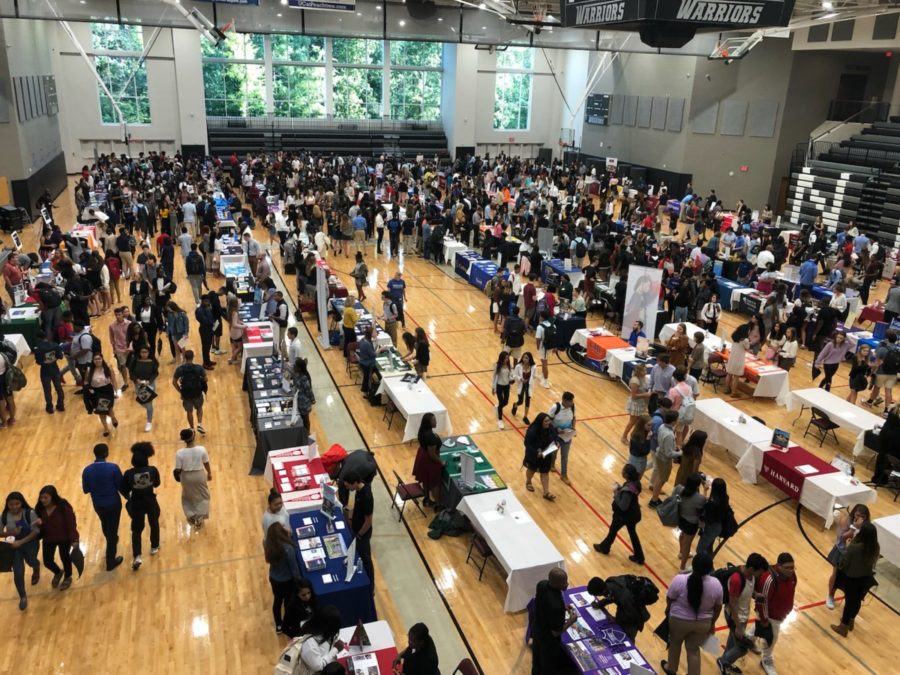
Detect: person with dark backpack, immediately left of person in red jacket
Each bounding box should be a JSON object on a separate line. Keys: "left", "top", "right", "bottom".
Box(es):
{"left": 716, "top": 553, "right": 769, "bottom": 675}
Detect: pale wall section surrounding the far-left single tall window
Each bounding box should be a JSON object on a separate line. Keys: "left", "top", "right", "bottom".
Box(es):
{"left": 47, "top": 23, "right": 206, "bottom": 173}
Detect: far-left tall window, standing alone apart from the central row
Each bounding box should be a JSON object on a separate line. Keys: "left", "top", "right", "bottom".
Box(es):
{"left": 91, "top": 23, "right": 150, "bottom": 124}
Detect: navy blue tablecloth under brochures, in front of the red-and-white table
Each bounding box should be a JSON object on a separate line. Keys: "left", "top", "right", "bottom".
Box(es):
{"left": 291, "top": 511, "right": 378, "bottom": 628}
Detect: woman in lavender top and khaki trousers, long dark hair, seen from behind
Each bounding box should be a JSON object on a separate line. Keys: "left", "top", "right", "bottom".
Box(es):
{"left": 660, "top": 555, "right": 724, "bottom": 675}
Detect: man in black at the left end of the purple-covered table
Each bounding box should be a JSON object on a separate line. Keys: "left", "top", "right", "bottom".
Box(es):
{"left": 531, "top": 567, "right": 580, "bottom": 675}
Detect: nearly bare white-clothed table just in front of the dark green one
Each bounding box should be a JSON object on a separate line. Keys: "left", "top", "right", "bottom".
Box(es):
{"left": 457, "top": 489, "right": 566, "bottom": 612}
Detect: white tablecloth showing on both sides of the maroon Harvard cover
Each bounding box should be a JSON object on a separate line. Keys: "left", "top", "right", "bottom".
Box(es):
{"left": 737, "top": 439, "right": 877, "bottom": 529}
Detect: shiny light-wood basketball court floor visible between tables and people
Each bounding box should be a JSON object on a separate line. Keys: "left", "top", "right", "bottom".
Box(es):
{"left": 0, "top": 186, "right": 900, "bottom": 675}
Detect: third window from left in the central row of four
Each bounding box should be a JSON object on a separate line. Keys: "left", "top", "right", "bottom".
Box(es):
{"left": 331, "top": 38, "right": 384, "bottom": 119}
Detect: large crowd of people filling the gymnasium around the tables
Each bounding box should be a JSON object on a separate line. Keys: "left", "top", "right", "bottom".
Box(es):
{"left": 0, "top": 147, "right": 900, "bottom": 675}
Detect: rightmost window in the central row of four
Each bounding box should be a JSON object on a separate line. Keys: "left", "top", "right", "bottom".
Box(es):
{"left": 390, "top": 41, "right": 443, "bottom": 120}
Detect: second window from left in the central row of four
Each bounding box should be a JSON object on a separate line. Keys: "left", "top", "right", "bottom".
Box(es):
{"left": 272, "top": 35, "right": 325, "bottom": 117}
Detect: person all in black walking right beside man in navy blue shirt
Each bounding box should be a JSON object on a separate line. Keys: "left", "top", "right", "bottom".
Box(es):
{"left": 121, "top": 443, "right": 160, "bottom": 572}
